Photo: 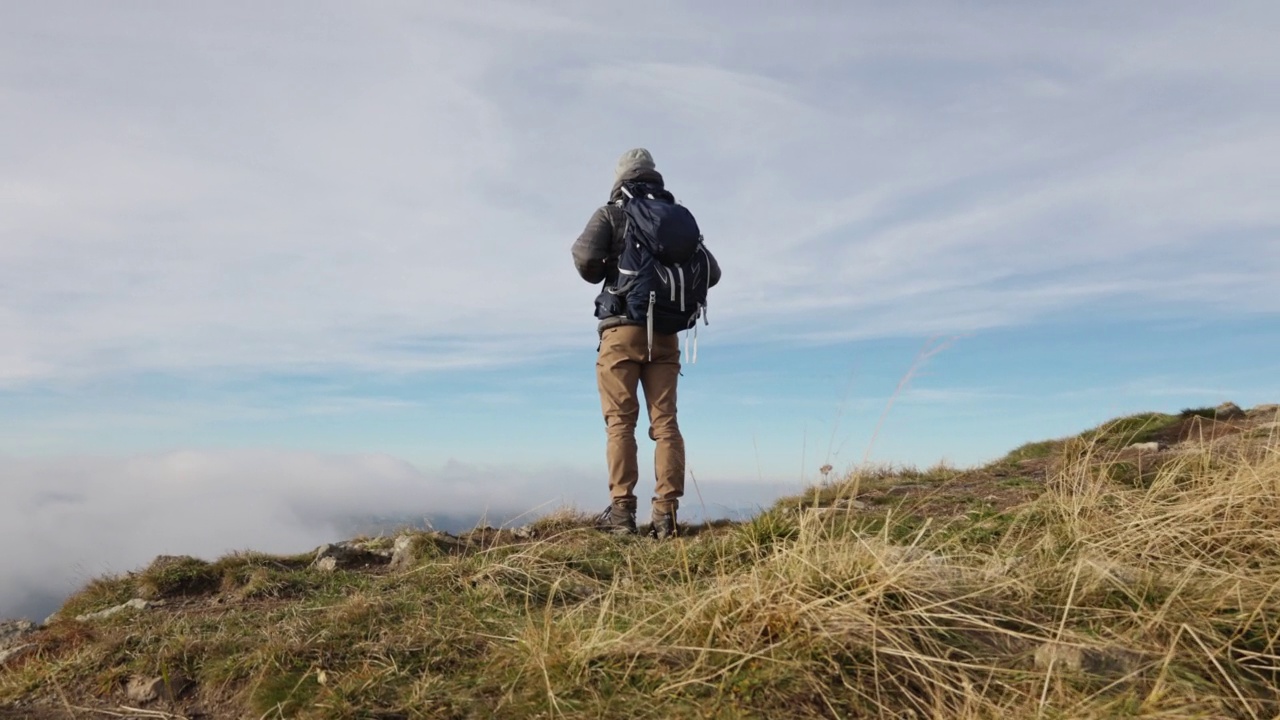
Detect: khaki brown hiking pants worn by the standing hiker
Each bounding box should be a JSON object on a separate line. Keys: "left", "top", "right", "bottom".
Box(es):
{"left": 595, "top": 325, "right": 685, "bottom": 512}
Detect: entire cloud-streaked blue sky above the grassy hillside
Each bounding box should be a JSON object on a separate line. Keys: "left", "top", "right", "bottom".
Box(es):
{"left": 0, "top": 1, "right": 1280, "bottom": 616}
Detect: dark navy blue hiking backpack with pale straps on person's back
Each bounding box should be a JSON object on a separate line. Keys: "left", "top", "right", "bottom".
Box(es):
{"left": 595, "top": 183, "right": 710, "bottom": 361}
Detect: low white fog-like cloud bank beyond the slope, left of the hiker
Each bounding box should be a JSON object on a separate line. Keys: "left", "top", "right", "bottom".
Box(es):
{"left": 0, "top": 451, "right": 604, "bottom": 618}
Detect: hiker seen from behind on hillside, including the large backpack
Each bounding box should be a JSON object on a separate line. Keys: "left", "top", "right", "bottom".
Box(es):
{"left": 573, "top": 147, "right": 721, "bottom": 539}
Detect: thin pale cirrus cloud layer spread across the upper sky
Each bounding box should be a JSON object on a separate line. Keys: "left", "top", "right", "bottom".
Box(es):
{"left": 0, "top": 3, "right": 1280, "bottom": 383}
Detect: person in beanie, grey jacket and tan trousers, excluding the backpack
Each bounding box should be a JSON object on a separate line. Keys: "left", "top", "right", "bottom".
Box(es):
{"left": 573, "top": 147, "right": 721, "bottom": 539}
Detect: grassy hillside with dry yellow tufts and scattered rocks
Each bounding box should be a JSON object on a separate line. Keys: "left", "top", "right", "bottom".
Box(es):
{"left": 0, "top": 406, "right": 1280, "bottom": 719}
